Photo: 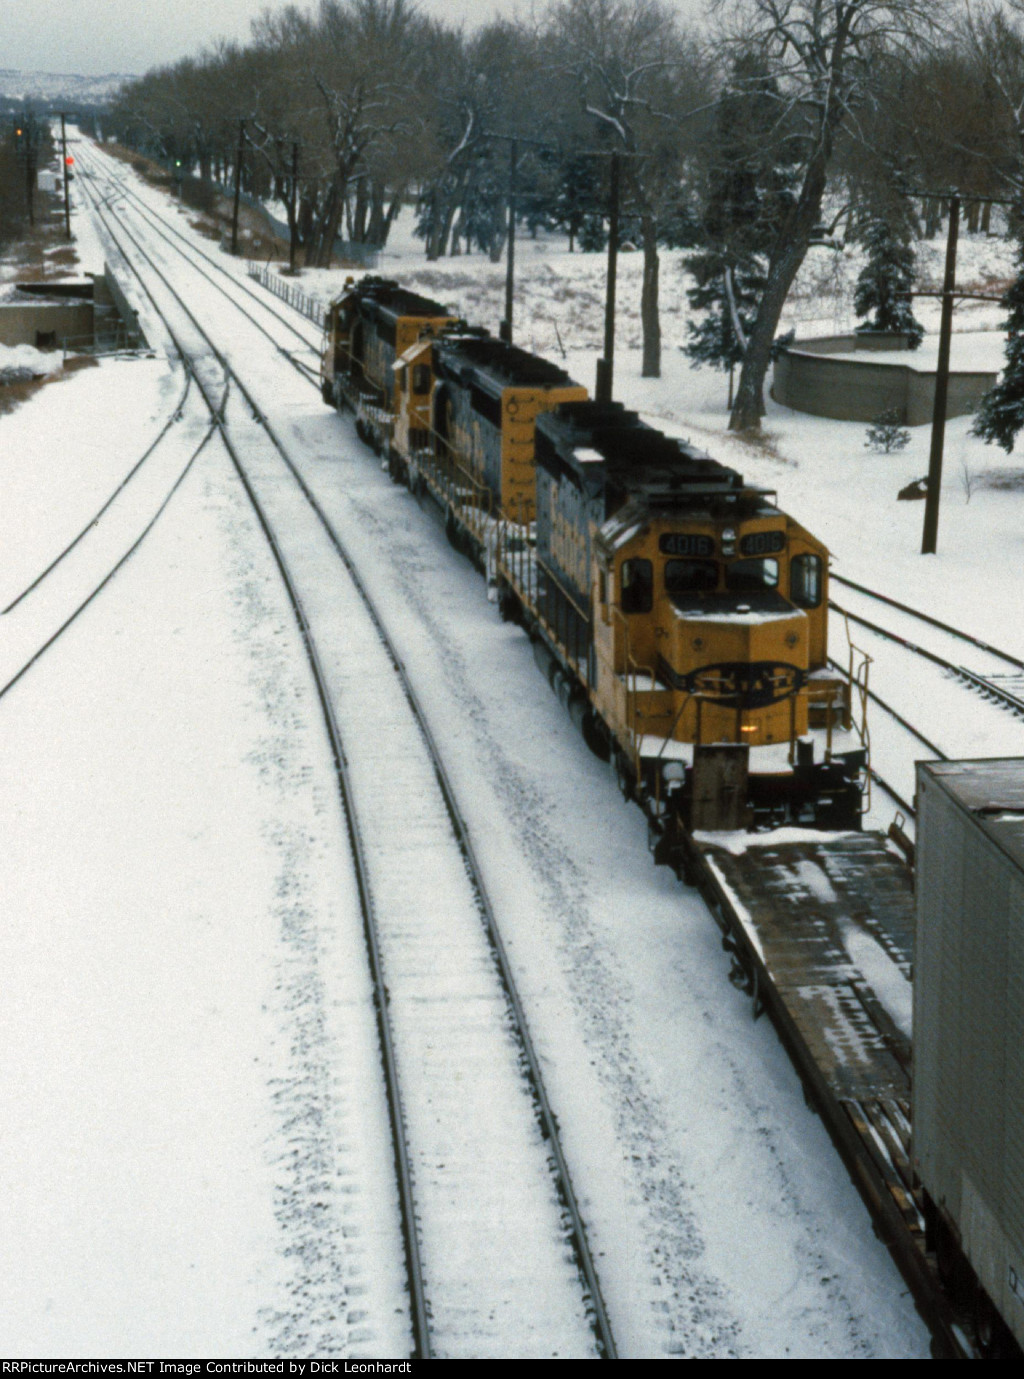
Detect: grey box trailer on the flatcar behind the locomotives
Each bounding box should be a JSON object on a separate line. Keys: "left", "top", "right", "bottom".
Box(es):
{"left": 912, "top": 760, "right": 1024, "bottom": 1358}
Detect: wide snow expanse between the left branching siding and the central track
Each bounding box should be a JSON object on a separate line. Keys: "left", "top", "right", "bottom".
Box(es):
{"left": 0, "top": 427, "right": 401, "bottom": 1357}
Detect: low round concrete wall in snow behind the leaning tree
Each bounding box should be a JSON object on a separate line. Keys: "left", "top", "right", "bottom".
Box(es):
{"left": 772, "top": 331, "right": 999, "bottom": 426}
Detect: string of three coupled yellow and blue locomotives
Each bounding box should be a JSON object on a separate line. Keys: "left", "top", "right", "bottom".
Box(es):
{"left": 324, "top": 279, "right": 867, "bottom": 843}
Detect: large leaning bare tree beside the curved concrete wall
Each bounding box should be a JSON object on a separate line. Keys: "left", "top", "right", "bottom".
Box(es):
{"left": 713, "top": 0, "right": 944, "bottom": 430}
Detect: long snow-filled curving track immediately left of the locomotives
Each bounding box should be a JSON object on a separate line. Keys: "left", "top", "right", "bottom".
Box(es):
{"left": 76, "top": 137, "right": 616, "bottom": 1357}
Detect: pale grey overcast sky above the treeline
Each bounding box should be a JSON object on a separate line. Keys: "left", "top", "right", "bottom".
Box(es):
{"left": 0, "top": 0, "right": 704, "bottom": 76}
